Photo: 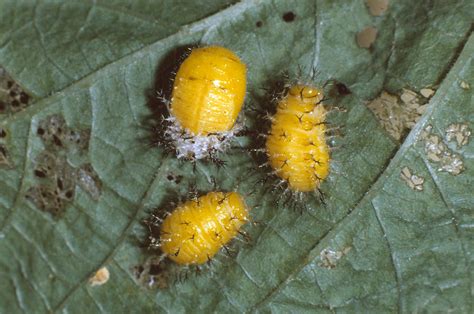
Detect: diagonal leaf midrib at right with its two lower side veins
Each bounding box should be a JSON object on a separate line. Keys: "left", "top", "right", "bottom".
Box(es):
{"left": 252, "top": 35, "right": 474, "bottom": 312}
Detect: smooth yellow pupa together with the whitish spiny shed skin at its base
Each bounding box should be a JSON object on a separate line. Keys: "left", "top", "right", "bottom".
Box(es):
{"left": 163, "top": 46, "right": 247, "bottom": 159}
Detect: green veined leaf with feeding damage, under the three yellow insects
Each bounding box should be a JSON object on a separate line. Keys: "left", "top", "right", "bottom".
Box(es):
{"left": 0, "top": 0, "right": 474, "bottom": 313}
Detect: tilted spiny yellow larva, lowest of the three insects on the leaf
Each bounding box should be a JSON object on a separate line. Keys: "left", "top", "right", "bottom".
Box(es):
{"left": 160, "top": 192, "right": 249, "bottom": 265}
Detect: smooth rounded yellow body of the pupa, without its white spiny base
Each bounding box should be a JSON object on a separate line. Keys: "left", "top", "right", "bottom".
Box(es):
{"left": 170, "top": 46, "right": 246, "bottom": 135}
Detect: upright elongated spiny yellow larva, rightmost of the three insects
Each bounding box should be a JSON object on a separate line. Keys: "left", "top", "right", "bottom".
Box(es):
{"left": 266, "top": 85, "right": 330, "bottom": 192}
